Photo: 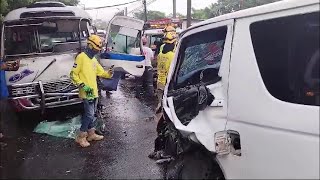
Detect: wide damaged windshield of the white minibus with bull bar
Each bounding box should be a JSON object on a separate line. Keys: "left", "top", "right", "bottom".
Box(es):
{"left": 5, "top": 20, "right": 89, "bottom": 56}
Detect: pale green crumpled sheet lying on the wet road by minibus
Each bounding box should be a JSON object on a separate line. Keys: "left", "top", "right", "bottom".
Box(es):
{"left": 33, "top": 115, "right": 81, "bottom": 139}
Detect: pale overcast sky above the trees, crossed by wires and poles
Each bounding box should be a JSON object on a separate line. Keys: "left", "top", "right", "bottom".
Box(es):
{"left": 80, "top": 0, "right": 216, "bottom": 20}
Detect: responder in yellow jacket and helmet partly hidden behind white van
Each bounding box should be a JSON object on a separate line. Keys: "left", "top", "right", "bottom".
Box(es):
{"left": 156, "top": 26, "right": 177, "bottom": 120}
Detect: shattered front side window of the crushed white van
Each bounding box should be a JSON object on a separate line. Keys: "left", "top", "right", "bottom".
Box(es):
{"left": 175, "top": 26, "right": 228, "bottom": 88}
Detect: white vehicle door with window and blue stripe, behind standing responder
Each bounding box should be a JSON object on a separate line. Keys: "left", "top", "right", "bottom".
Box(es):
{"left": 100, "top": 16, "right": 145, "bottom": 77}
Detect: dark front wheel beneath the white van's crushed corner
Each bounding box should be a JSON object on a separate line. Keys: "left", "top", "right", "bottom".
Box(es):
{"left": 166, "top": 152, "right": 224, "bottom": 179}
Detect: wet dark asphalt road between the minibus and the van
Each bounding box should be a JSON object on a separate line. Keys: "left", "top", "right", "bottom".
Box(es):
{"left": 0, "top": 80, "right": 163, "bottom": 179}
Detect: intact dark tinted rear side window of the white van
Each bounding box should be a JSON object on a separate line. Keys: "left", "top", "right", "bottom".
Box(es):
{"left": 250, "top": 12, "right": 320, "bottom": 106}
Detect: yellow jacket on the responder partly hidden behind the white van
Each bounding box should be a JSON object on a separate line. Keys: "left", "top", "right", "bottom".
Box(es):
{"left": 157, "top": 44, "right": 174, "bottom": 89}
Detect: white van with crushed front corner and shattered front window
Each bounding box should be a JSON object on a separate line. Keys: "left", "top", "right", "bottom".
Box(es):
{"left": 156, "top": 0, "right": 320, "bottom": 179}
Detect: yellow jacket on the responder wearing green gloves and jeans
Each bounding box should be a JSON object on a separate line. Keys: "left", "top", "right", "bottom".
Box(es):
{"left": 70, "top": 52, "right": 112, "bottom": 99}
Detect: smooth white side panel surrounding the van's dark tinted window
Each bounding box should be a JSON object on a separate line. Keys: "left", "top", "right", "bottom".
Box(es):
{"left": 218, "top": 5, "right": 319, "bottom": 179}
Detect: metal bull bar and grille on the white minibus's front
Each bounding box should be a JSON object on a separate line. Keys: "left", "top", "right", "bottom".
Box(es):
{"left": 8, "top": 79, "right": 82, "bottom": 112}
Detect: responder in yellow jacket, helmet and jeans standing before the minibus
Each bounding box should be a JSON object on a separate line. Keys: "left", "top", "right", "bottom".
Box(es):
{"left": 70, "top": 35, "right": 113, "bottom": 147}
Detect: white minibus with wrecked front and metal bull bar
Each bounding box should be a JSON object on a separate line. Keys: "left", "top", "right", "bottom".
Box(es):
{"left": 1, "top": 2, "right": 92, "bottom": 111}
